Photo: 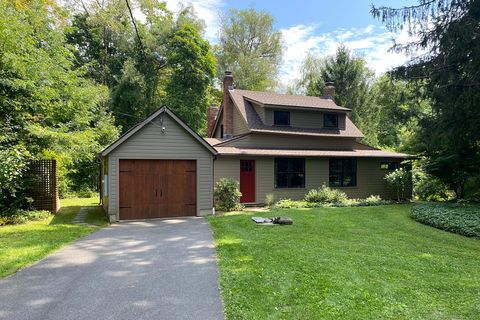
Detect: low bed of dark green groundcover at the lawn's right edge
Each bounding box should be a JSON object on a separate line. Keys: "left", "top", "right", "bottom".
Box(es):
{"left": 410, "top": 203, "right": 480, "bottom": 237}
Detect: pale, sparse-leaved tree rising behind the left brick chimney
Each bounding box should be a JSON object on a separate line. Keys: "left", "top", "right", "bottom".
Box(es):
{"left": 215, "top": 9, "right": 282, "bottom": 91}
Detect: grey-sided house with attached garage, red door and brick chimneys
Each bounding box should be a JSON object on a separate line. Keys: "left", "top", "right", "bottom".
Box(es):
{"left": 101, "top": 72, "right": 407, "bottom": 220}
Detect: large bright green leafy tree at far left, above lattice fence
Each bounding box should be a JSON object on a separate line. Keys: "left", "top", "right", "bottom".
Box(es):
{"left": 0, "top": 0, "right": 117, "bottom": 200}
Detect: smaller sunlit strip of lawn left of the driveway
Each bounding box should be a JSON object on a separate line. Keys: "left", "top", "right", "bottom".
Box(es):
{"left": 0, "top": 197, "right": 107, "bottom": 278}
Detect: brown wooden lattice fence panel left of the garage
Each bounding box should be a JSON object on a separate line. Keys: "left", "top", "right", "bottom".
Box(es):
{"left": 28, "top": 160, "right": 60, "bottom": 213}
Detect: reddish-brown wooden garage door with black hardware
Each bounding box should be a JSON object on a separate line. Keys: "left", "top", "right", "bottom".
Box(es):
{"left": 120, "top": 160, "right": 197, "bottom": 220}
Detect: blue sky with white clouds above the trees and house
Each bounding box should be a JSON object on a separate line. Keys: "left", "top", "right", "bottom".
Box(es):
{"left": 162, "top": 0, "right": 416, "bottom": 90}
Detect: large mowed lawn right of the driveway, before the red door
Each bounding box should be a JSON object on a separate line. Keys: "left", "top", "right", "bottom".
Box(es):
{"left": 209, "top": 205, "right": 480, "bottom": 320}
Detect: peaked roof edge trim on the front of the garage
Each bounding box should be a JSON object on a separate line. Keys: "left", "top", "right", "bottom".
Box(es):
{"left": 100, "top": 107, "right": 217, "bottom": 156}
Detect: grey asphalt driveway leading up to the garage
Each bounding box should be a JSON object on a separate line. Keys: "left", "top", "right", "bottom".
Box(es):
{"left": 0, "top": 218, "right": 223, "bottom": 320}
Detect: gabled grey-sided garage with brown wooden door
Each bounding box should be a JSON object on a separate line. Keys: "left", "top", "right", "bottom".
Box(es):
{"left": 100, "top": 107, "right": 217, "bottom": 221}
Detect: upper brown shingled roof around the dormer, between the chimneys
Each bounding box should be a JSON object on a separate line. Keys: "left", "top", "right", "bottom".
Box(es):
{"left": 229, "top": 89, "right": 363, "bottom": 138}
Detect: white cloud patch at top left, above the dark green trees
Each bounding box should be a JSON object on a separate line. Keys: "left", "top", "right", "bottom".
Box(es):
{"left": 166, "top": 0, "right": 225, "bottom": 43}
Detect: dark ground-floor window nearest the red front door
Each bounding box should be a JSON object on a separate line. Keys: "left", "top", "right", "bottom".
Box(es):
{"left": 275, "top": 158, "right": 305, "bottom": 188}
